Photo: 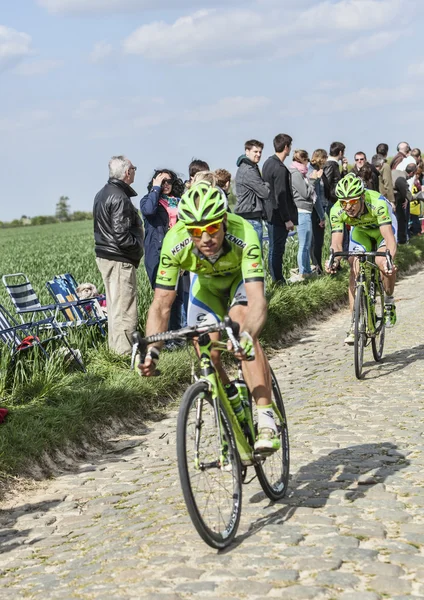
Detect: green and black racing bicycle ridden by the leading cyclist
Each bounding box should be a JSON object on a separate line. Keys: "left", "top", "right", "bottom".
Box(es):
{"left": 132, "top": 317, "right": 290, "bottom": 550}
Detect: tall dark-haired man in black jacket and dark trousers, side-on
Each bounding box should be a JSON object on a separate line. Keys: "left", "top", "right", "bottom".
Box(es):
{"left": 262, "top": 133, "right": 297, "bottom": 284}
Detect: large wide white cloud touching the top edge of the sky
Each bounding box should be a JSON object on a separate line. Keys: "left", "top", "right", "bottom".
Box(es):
{"left": 123, "top": 0, "right": 406, "bottom": 66}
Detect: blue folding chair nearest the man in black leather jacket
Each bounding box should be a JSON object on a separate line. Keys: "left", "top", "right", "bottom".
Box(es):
{"left": 46, "top": 273, "right": 107, "bottom": 336}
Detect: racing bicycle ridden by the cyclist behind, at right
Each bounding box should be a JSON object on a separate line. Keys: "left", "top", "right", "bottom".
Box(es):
{"left": 328, "top": 250, "right": 393, "bottom": 379}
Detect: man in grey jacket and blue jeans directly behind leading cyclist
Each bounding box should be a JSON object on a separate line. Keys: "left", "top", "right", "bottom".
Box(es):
{"left": 234, "top": 140, "right": 269, "bottom": 246}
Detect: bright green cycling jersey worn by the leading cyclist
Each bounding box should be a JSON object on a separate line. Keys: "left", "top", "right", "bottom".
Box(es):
{"left": 156, "top": 213, "right": 264, "bottom": 325}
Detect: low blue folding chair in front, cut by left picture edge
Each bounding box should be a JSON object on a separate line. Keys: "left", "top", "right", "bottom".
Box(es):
{"left": 0, "top": 304, "right": 86, "bottom": 372}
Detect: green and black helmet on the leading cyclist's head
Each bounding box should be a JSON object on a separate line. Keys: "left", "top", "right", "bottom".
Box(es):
{"left": 178, "top": 181, "right": 227, "bottom": 225}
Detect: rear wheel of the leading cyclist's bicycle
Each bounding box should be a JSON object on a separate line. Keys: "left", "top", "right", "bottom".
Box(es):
{"left": 255, "top": 369, "right": 290, "bottom": 500}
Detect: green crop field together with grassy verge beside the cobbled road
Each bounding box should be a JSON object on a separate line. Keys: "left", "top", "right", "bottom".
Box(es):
{"left": 0, "top": 221, "right": 424, "bottom": 479}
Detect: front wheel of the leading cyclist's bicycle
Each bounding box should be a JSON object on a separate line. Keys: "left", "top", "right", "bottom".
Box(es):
{"left": 177, "top": 381, "right": 242, "bottom": 550}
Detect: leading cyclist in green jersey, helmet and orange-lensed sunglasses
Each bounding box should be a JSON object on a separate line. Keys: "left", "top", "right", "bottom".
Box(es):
{"left": 140, "top": 181, "right": 280, "bottom": 453}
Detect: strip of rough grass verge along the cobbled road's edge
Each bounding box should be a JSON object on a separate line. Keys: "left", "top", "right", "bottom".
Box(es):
{"left": 0, "top": 236, "right": 424, "bottom": 482}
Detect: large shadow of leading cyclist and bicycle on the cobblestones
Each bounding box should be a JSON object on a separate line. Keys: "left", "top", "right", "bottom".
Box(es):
{"left": 227, "top": 442, "right": 410, "bottom": 552}
